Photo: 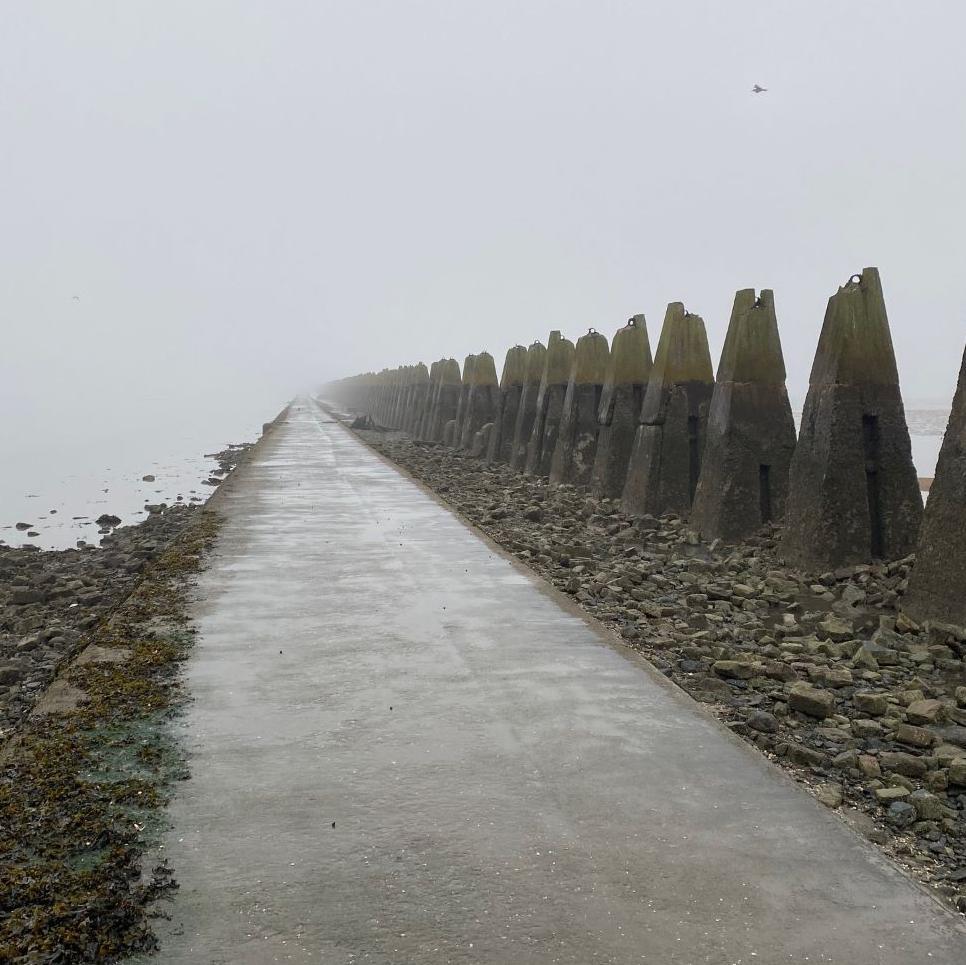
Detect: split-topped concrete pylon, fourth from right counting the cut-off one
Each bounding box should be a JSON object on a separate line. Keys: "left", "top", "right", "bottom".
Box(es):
{"left": 621, "top": 302, "right": 714, "bottom": 516}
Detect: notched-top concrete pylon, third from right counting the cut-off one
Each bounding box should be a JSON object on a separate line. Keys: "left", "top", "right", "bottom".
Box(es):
{"left": 691, "top": 288, "right": 795, "bottom": 542}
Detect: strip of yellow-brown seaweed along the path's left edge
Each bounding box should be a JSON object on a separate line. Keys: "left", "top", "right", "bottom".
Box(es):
{"left": 0, "top": 510, "right": 218, "bottom": 963}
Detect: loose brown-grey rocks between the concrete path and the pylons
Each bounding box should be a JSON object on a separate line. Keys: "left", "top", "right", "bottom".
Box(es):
{"left": 358, "top": 429, "right": 966, "bottom": 912}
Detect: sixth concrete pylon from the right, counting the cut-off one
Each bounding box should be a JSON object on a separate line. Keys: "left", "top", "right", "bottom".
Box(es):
{"left": 550, "top": 329, "right": 610, "bottom": 486}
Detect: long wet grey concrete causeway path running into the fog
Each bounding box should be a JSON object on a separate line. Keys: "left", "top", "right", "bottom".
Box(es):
{"left": 152, "top": 400, "right": 966, "bottom": 965}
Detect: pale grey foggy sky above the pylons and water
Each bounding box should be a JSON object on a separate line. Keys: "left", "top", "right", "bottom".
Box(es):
{"left": 0, "top": 0, "right": 966, "bottom": 456}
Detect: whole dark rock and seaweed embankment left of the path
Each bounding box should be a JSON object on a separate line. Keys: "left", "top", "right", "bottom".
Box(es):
{"left": 0, "top": 423, "right": 271, "bottom": 965}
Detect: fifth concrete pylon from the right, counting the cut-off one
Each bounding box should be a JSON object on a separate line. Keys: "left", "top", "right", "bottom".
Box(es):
{"left": 590, "top": 315, "right": 653, "bottom": 499}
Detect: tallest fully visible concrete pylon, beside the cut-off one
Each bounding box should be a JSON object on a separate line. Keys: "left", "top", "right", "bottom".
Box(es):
{"left": 782, "top": 268, "right": 922, "bottom": 570}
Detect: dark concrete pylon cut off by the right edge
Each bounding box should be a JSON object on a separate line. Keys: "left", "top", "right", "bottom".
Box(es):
{"left": 902, "top": 342, "right": 966, "bottom": 627}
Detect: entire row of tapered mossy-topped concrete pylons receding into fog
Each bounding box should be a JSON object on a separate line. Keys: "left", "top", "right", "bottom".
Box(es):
{"left": 328, "top": 268, "right": 966, "bottom": 625}
